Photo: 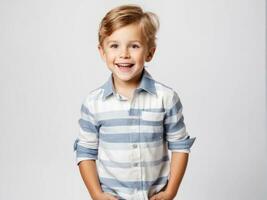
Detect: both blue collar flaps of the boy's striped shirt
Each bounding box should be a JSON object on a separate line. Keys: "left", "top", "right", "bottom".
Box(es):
{"left": 101, "top": 68, "right": 157, "bottom": 100}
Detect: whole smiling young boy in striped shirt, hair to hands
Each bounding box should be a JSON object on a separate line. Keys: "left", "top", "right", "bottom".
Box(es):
{"left": 74, "top": 5, "right": 195, "bottom": 200}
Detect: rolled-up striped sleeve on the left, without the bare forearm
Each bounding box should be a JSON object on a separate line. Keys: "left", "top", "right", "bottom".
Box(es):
{"left": 73, "top": 100, "right": 99, "bottom": 165}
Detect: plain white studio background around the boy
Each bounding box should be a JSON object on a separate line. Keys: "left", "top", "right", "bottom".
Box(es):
{"left": 0, "top": 0, "right": 267, "bottom": 200}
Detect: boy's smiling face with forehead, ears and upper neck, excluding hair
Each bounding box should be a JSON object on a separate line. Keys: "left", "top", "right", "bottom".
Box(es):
{"left": 99, "top": 24, "right": 155, "bottom": 84}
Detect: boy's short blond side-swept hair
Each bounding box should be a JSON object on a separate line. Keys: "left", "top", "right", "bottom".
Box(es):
{"left": 98, "top": 5, "right": 159, "bottom": 48}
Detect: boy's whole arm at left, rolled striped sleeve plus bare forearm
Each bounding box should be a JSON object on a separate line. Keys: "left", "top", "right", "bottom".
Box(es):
{"left": 73, "top": 99, "right": 119, "bottom": 200}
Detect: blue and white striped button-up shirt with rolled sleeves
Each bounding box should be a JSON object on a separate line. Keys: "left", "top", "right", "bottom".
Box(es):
{"left": 74, "top": 68, "right": 195, "bottom": 200}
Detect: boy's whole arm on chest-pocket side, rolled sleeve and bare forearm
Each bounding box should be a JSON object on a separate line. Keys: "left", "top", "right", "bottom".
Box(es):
{"left": 150, "top": 91, "right": 196, "bottom": 200}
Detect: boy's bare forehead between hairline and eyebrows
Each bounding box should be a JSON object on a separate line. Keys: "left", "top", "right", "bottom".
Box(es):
{"left": 104, "top": 24, "right": 145, "bottom": 43}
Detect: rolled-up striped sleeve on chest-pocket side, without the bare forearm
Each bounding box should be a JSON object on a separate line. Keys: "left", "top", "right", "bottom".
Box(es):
{"left": 164, "top": 91, "right": 196, "bottom": 153}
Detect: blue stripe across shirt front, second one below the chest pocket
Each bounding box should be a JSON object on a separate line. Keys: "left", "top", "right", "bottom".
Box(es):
{"left": 99, "top": 132, "right": 163, "bottom": 143}
